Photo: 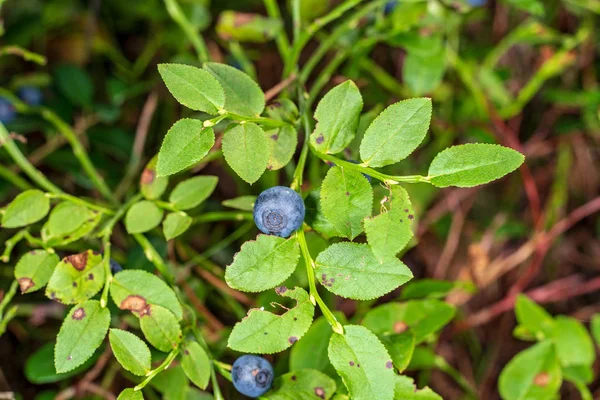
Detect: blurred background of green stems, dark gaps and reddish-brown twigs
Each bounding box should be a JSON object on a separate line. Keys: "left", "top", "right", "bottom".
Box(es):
{"left": 0, "top": 0, "right": 600, "bottom": 399}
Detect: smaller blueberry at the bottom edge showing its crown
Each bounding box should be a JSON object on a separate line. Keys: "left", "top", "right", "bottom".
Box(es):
{"left": 231, "top": 354, "right": 273, "bottom": 398}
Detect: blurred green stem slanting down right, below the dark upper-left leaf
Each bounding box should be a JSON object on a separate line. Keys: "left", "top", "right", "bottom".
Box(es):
{"left": 41, "top": 108, "right": 117, "bottom": 204}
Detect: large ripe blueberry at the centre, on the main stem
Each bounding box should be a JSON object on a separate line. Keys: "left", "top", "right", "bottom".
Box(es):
{"left": 254, "top": 186, "right": 305, "bottom": 237}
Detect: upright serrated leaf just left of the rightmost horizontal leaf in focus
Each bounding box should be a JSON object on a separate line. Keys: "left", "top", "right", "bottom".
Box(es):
{"left": 360, "top": 98, "right": 431, "bottom": 167}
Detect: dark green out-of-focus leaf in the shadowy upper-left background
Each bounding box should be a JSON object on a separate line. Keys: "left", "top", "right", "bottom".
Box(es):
{"left": 54, "top": 64, "right": 94, "bottom": 107}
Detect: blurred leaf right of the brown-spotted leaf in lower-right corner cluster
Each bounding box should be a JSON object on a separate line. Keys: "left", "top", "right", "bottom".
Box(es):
{"left": 553, "top": 315, "right": 596, "bottom": 367}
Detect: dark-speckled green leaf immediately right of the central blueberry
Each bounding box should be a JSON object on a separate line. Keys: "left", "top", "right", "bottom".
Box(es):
{"left": 321, "top": 166, "right": 373, "bottom": 240}
